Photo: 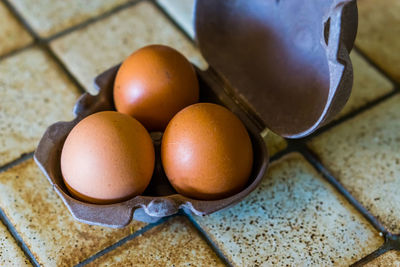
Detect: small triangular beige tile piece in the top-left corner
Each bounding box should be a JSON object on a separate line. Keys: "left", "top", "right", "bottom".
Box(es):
{"left": 0, "top": 2, "right": 32, "bottom": 55}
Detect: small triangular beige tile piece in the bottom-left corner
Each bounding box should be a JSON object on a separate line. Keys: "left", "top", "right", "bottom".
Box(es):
{"left": 0, "top": 222, "right": 32, "bottom": 266}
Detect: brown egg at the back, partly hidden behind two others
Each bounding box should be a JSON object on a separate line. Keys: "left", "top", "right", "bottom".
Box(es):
{"left": 114, "top": 45, "right": 199, "bottom": 131}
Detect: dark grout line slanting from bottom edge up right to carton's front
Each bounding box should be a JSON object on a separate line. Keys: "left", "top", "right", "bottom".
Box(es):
{"left": 75, "top": 214, "right": 178, "bottom": 267}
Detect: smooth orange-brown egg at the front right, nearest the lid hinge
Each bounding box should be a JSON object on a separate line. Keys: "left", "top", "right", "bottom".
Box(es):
{"left": 161, "top": 103, "right": 253, "bottom": 199}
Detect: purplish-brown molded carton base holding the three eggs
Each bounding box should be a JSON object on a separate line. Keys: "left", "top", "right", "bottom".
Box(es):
{"left": 34, "top": 66, "right": 268, "bottom": 228}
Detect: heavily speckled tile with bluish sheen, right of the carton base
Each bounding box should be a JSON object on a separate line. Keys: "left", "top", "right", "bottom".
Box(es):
{"left": 195, "top": 154, "right": 383, "bottom": 266}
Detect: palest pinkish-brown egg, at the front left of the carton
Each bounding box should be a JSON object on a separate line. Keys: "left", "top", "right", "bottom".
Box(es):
{"left": 61, "top": 111, "right": 155, "bottom": 204}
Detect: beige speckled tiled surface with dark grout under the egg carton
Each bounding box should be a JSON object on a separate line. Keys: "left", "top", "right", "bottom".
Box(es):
{"left": 0, "top": 0, "right": 400, "bottom": 266}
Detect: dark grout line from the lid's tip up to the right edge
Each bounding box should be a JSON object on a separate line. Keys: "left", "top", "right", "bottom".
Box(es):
{"left": 297, "top": 89, "right": 400, "bottom": 142}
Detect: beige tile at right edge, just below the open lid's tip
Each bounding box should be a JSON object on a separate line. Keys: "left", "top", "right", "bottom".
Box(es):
{"left": 309, "top": 96, "right": 400, "bottom": 232}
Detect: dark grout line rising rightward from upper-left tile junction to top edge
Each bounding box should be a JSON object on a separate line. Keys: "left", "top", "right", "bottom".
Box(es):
{"left": 43, "top": 0, "right": 143, "bottom": 42}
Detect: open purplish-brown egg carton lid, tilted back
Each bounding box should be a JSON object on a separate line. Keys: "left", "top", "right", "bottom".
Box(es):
{"left": 194, "top": 0, "right": 358, "bottom": 138}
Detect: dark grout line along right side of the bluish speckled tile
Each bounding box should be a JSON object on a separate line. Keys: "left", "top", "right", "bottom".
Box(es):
{"left": 300, "top": 147, "right": 389, "bottom": 237}
